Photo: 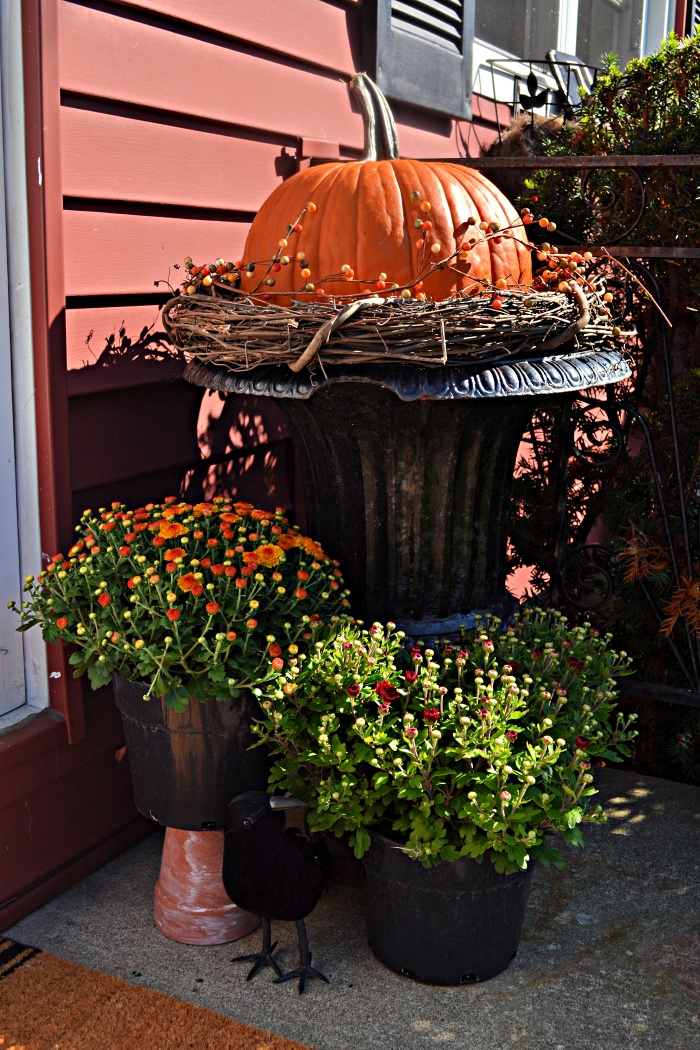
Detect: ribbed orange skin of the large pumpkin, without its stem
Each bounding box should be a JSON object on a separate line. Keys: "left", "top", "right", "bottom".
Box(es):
{"left": 242, "top": 160, "right": 532, "bottom": 305}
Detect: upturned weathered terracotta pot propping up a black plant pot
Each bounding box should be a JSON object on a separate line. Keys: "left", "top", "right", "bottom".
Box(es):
{"left": 153, "top": 827, "right": 260, "bottom": 944}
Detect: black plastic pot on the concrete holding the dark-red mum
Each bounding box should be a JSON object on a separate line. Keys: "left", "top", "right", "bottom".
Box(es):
{"left": 363, "top": 834, "right": 535, "bottom": 985}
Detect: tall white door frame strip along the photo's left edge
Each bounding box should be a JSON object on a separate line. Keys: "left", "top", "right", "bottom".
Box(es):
{"left": 0, "top": 0, "right": 49, "bottom": 733}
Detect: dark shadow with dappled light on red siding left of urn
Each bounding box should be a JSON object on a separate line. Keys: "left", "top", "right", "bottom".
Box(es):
{"left": 68, "top": 323, "right": 296, "bottom": 517}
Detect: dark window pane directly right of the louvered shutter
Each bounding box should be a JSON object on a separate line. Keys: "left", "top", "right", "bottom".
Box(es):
{"left": 474, "top": 0, "right": 562, "bottom": 59}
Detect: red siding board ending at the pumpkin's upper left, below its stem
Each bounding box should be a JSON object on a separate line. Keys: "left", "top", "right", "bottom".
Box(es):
{"left": 61, "top": 105, "right": 295, "bottom": 211}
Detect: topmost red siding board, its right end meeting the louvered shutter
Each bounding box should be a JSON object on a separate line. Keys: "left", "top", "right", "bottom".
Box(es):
{"left": 110, "top": 0, "right": 361, "bottom": 76}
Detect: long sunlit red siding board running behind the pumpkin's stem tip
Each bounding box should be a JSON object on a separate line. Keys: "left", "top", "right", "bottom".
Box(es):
{"left": 60, "top": 0, "right": 454, "bottom": 155}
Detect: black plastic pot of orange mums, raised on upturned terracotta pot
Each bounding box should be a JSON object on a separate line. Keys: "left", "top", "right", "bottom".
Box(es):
{"left": 113, "top": 675, "right": 270, "bottom": 832}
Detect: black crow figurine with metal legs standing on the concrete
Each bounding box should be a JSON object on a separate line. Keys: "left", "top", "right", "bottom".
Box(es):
{"left": 221, "top": 791, "right": 330, "bottom": 994}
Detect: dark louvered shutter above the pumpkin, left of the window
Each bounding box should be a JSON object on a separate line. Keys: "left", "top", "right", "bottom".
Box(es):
{"left": 375, "top": 0, "right": 474, "bottom": 120}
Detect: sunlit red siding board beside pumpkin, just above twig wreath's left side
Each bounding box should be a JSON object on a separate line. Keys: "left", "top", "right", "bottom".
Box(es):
{"left": 64, "top": 209, "right": 248, "bottom": 295}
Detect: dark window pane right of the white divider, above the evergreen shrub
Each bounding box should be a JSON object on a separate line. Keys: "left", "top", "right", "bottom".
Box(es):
{"left": 576, "top": 0, "right": 644, "bottom": 68}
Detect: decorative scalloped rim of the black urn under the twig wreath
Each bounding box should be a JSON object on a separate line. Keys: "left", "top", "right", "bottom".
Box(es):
{"left": 184, "top": 348, "right": 632, "bottom": 401}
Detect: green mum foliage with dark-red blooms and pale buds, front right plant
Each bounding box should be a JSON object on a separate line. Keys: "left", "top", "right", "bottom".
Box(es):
{"left": 255, "top": 610, "right": 635, "bottom": 872}
